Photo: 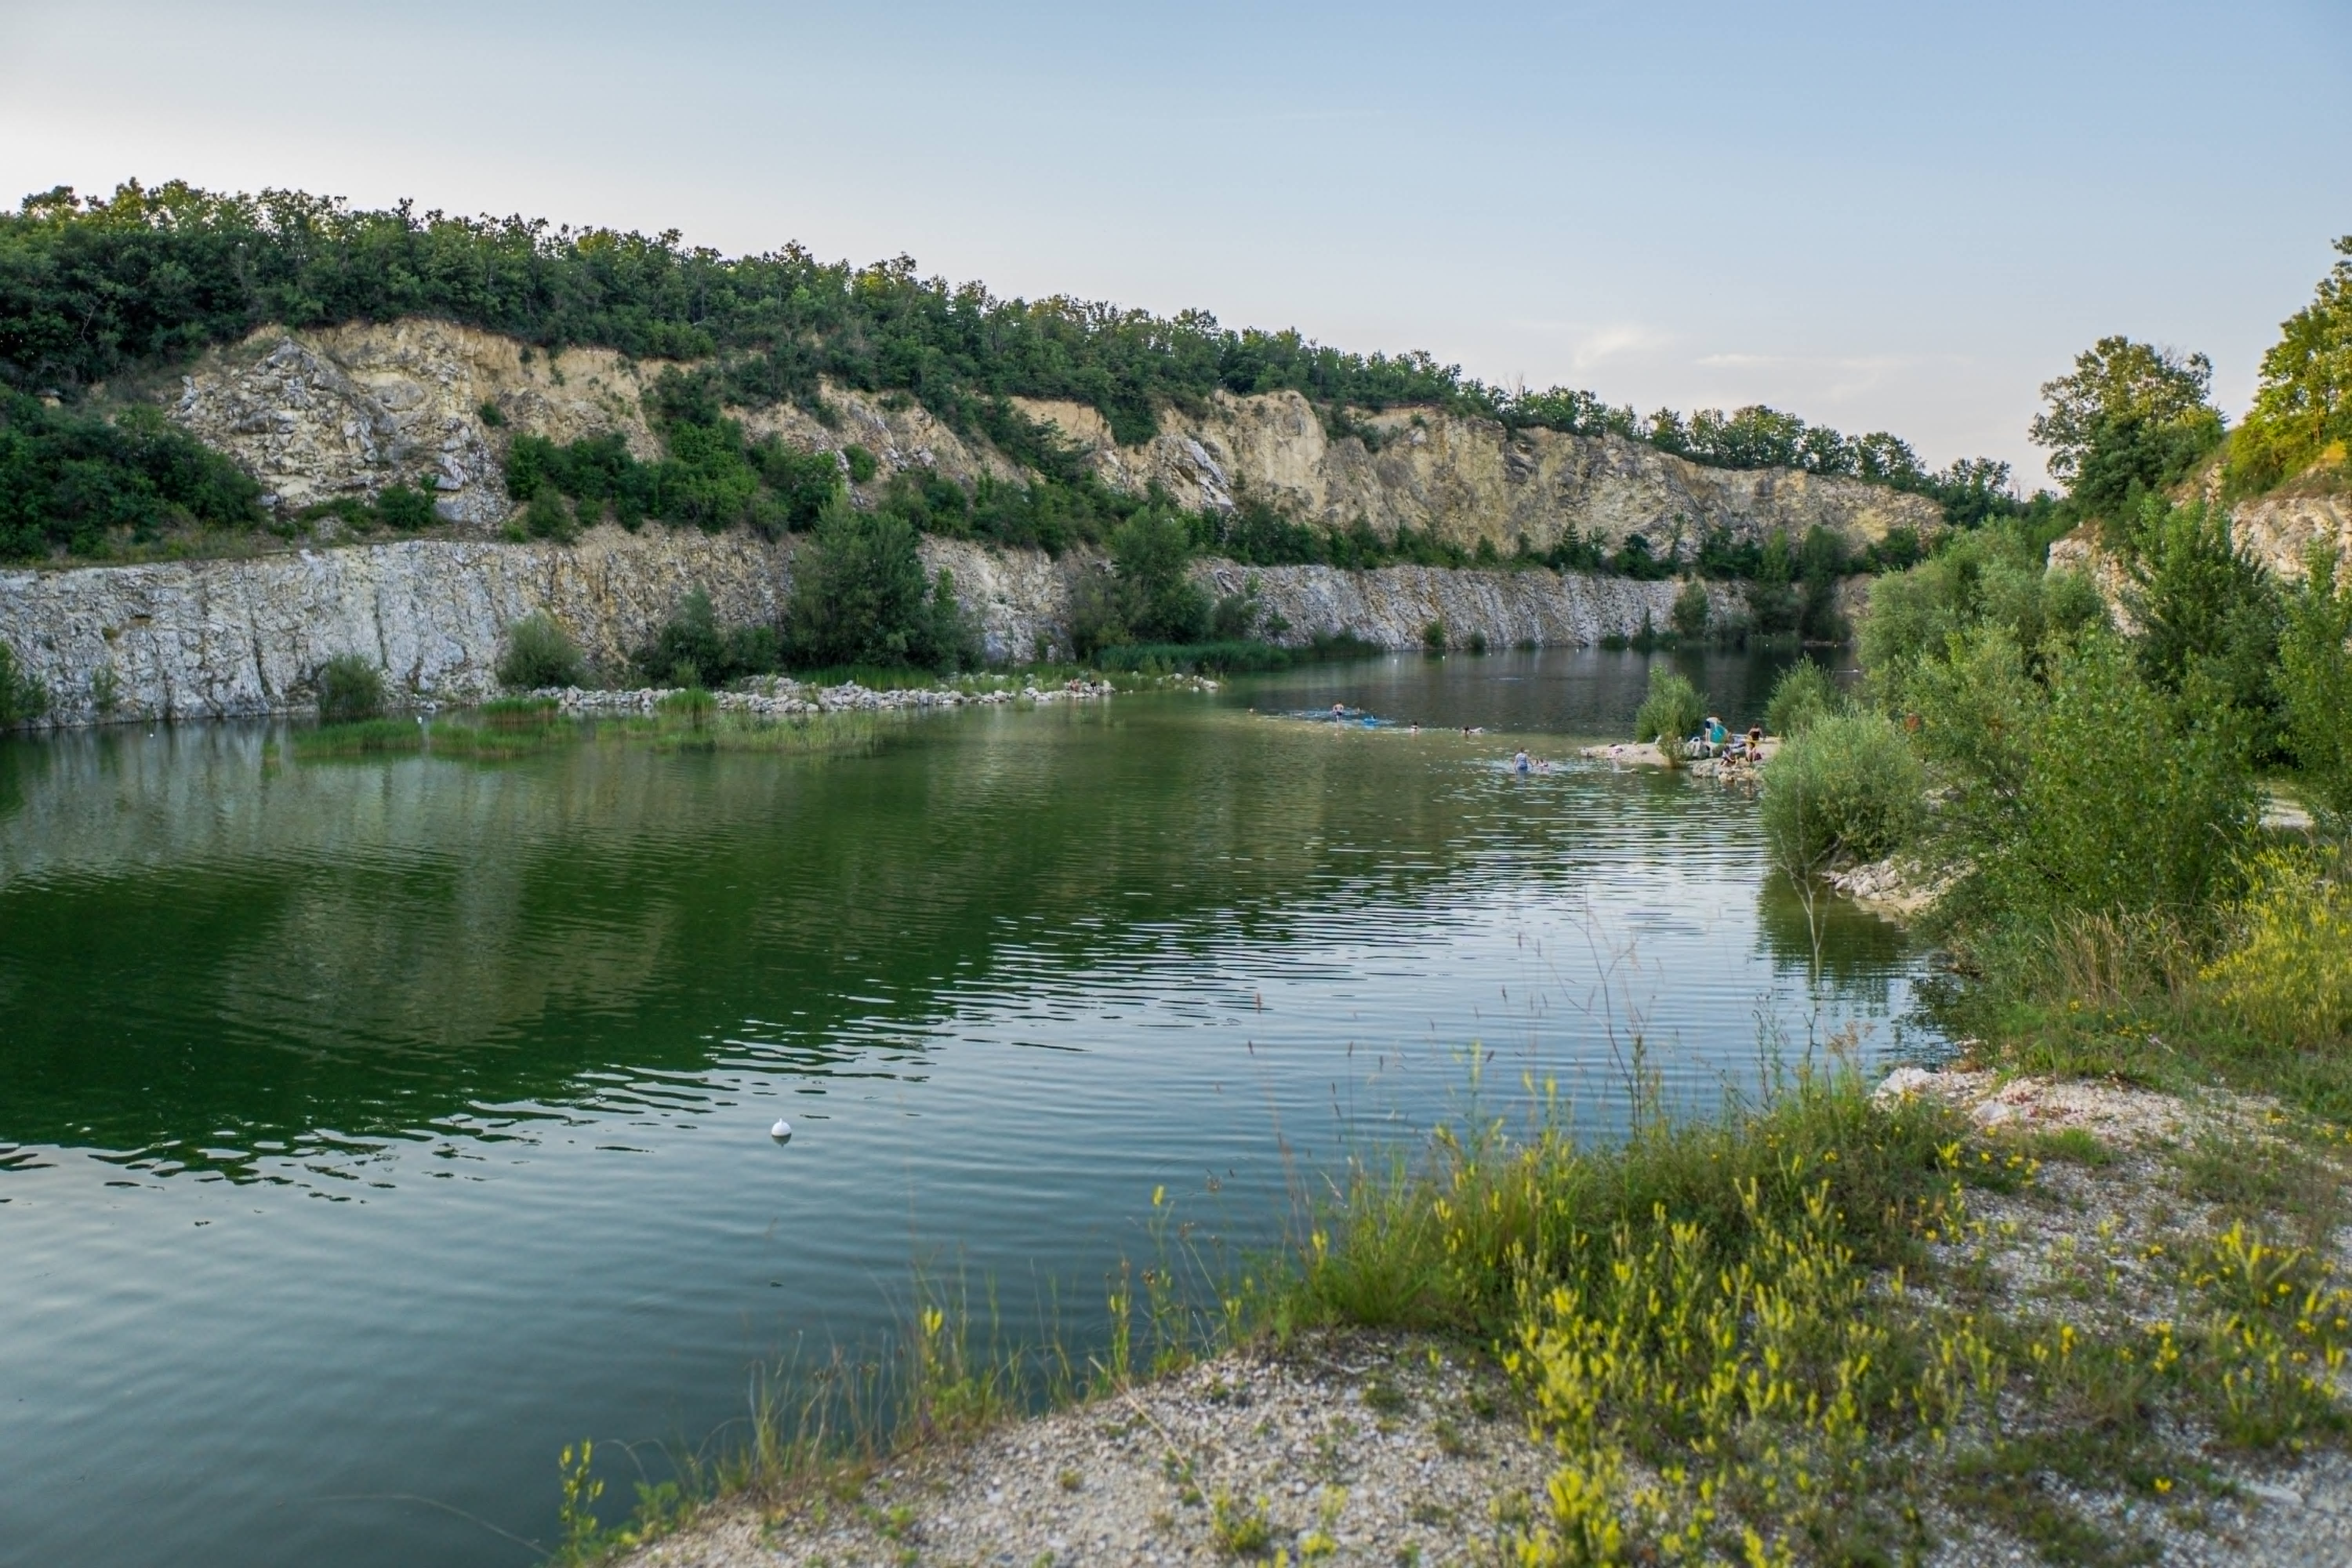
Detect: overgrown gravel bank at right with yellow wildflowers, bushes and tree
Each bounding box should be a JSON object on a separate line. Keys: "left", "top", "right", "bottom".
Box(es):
{"left": 574, "top": 312, "right": 2352, "bottom": 1566}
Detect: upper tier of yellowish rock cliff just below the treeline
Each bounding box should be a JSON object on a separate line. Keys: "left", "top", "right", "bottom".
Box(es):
{"left": 167, "top": 322, "right": 1940, "bottom": 555}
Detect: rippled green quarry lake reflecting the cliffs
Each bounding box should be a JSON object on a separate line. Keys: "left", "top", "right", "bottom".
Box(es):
{"left": 0, "top": 651, "right": 1931, "bottom": 1568}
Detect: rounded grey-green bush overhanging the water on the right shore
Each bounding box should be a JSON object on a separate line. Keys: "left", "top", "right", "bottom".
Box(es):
{"left": 1762, "top": 710, "right": 1926, "bottom": 877}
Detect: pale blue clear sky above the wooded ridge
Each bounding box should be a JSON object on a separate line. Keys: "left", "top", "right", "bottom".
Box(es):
{"left": 0, "top": 0, "right": 2352, "bottom": 482}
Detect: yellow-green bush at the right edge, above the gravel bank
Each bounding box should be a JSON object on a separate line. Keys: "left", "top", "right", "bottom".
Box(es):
{"left": 2204, "top": 849, "right": 2352, "bottom": 1046}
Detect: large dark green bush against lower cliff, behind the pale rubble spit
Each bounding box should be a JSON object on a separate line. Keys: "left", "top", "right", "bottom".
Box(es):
{"left": 793, "top": 501, "right": 971, "bottom": 670}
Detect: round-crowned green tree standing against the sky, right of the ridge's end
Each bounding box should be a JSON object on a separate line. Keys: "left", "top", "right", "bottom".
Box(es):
{"left": 2027, "top": 336, "right": 2223, "bottom": 517}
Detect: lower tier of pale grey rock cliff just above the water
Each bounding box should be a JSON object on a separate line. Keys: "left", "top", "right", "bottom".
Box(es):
{"left": 0, "top": 526, "right": 1731, "bottom": 724}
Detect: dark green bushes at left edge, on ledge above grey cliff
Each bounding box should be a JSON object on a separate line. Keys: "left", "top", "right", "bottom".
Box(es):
{"left": 0, "top": 395, "right": 263, "bottom": 559}
